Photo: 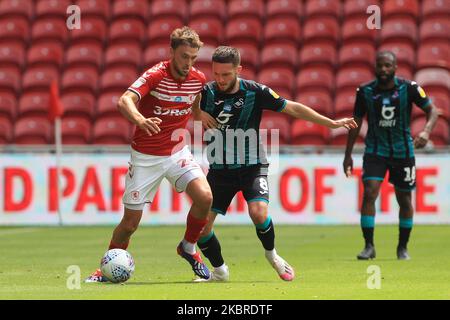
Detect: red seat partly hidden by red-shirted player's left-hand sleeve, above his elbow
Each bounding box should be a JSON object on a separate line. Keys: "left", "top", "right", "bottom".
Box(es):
{"left": 100, "top": 67, "right": 138, "bottom": 92}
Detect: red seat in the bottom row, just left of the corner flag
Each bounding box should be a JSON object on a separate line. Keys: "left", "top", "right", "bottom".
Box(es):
{"left": 14, "top": 117, "right": 52, "bottom": 144}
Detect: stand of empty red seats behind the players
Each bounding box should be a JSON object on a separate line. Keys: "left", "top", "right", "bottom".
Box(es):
{"left": 0, "top": 0, "right": 450, "bottom": 145}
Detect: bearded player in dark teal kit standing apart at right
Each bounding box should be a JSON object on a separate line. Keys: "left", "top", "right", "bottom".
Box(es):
{"left": 343, "top": 51, "right": 439, "bottom": 260}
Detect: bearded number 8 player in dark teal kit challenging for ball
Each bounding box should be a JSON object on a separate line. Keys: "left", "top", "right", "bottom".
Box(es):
{"left": 194, "top": 47, "right": 356, "bottom": 281}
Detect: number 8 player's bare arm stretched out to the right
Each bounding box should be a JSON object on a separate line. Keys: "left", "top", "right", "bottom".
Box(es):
{"left": 283, "top": 100, "right": 357, "bottom": 130}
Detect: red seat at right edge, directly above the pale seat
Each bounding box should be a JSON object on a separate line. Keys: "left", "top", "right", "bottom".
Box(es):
{"left": 417, "top": 41, "right": 450, "bottom": 69}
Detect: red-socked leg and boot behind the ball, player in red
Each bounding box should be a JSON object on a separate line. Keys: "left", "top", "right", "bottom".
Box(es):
{"left": 85, "top": 208, "right": 142, "bottom": 282}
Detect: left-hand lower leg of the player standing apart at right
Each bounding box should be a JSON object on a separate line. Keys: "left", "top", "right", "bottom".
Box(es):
{"left": 357, "top": 180, "right": 382, "bottom": 260}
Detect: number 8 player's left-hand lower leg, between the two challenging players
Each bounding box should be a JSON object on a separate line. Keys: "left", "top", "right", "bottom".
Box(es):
{"left": 196, "top": 211, "right": 230, "bottom": 281}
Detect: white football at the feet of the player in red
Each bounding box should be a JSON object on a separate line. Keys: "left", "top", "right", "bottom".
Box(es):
{"left": 100, "top": 249, "right": 134, "bottom": 283}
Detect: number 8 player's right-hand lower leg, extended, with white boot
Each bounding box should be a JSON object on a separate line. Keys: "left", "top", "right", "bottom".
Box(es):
{"left": 248, "top": 201, "right": 295, "bottom": 281}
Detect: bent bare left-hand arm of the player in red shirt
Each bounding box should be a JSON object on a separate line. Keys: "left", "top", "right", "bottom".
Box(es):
{"left": 117, "top": 90, "right": 161, "bottom": 136}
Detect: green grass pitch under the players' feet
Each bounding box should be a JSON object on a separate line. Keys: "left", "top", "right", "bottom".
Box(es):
{"left": 0, "top": 225, "right": 450, "bottom": 300}
